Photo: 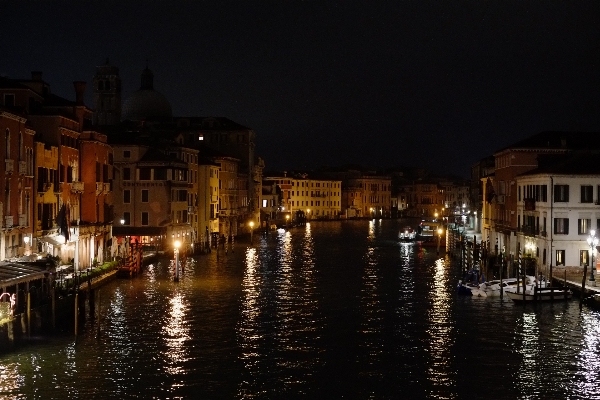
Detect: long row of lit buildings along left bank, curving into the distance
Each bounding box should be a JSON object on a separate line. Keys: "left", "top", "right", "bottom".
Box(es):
{"left": 0, "top": 60, "right": 468, "bottom": 268}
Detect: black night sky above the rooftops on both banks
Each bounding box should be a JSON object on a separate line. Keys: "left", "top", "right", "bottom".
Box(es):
{"left": 0, "top": 0, "right": 600, "bottom": 177}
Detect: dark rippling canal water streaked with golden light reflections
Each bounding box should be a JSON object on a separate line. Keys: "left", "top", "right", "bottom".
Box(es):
{"left": 0, "top": 220, "right": 600, "bottom": 399}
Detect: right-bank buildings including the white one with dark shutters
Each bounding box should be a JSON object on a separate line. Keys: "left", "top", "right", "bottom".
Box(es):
{"left": 472, "top": 132, "right": 600, "bottom": 275}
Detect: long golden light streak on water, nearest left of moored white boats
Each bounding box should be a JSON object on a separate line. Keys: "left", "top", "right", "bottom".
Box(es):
{"left": 427, "top": 258, "right": 457, "bottom": 398}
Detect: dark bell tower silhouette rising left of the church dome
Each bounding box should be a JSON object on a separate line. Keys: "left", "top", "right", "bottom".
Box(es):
{"left": 94, "top": 58, "right": 121, "bottom": 126}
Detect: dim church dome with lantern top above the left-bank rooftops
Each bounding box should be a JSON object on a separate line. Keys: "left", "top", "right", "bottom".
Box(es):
{"left": 122, "top": 68, "right": 173, "bottom": 121}
